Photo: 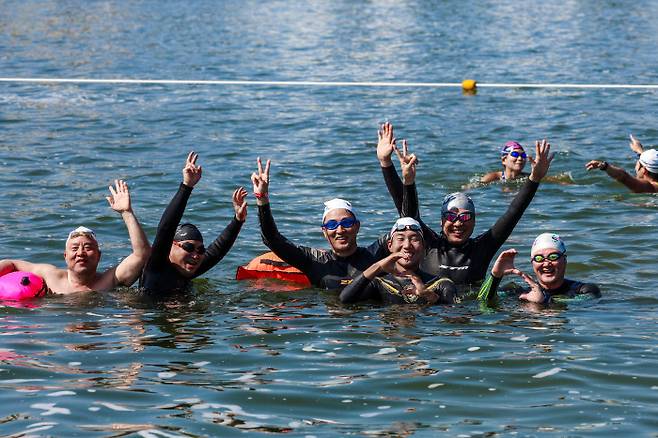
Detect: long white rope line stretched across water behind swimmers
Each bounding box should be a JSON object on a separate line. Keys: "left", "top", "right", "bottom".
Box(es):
{"left": 0, "top": 77, "right": 658, "bottom": 90}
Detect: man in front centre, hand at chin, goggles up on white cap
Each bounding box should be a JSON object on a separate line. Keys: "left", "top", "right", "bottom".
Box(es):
{"left": 340, "top": 217, "right": 456, "bottom": 305}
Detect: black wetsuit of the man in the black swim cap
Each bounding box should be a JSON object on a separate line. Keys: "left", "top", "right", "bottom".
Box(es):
{"left": 139, "top": 183, "right": 243, "bottom": 297}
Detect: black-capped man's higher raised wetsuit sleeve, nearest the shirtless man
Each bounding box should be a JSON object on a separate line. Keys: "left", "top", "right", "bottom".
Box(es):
{"left": 147, "top": 183, "right": 192, "bottom": 267}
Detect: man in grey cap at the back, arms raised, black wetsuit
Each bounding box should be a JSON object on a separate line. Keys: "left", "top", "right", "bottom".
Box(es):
{"left": 377, "top": 123, "right": 553, "bottom": 292}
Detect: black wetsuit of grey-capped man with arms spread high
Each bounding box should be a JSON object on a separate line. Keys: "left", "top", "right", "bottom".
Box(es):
{"left": 382, "top": 166, "right": 539, "bottom": 290}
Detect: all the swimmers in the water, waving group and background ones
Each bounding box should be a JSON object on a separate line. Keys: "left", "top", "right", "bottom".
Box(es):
{"left": 0, "top": 123, "right": 658, "bottom": 304}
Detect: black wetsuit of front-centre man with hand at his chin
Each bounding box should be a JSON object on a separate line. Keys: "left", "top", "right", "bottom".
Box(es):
{"left": 340, "top": 271, "right": 456, "bottom": 304}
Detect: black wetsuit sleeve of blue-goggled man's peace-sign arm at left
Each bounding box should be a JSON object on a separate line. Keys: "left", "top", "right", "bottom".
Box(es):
{"left": 258, "top": 204, "right": 314, "bottom": 275}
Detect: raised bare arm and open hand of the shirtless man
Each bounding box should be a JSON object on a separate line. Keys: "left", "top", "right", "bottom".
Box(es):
{"left": 103, "top": 180, "right": 151, "bottom": 286}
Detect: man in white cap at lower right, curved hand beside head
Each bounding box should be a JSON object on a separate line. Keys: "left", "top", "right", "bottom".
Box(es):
{"left": 478, "top": 233, "right": 601, "bottom": 304}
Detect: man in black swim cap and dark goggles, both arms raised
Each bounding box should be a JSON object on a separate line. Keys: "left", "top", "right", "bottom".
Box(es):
{"left": 139, "top": 152, "right": 247, "bottom": 298}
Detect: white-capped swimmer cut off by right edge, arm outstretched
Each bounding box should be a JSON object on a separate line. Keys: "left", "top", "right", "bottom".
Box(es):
{"left": 585, "top": 135, "right": 658, "bottom": 193}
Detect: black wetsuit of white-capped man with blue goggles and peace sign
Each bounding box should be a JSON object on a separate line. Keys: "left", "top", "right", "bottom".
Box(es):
{"left": 258, "top": 204, "right": 388, "bottom": 290}
